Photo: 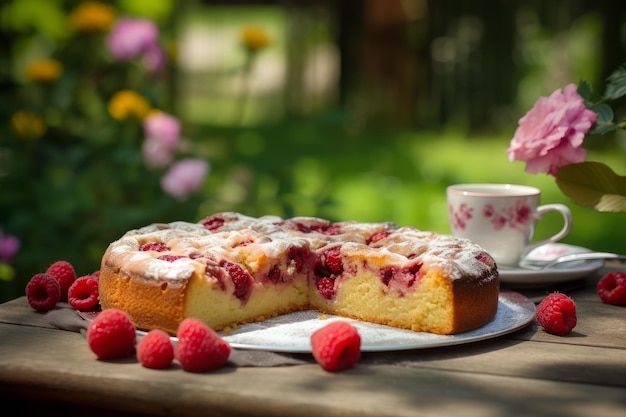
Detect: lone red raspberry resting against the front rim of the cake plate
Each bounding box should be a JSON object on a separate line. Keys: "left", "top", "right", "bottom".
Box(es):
{"left": 311, "top": 321, "right": 361, "bottom": 372}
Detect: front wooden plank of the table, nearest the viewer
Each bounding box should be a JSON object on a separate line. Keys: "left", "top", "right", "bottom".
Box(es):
{"left": 1, "top": 342, "right": 626, "bottom": 417}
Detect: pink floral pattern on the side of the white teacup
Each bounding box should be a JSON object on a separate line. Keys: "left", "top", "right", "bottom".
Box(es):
{"left": 448, "top": 200, "right": 532, "bottom": 230}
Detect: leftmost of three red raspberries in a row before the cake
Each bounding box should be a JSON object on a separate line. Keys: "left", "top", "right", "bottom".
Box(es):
{"left": 87, "top": 308, "right": 137, "bottom": 360}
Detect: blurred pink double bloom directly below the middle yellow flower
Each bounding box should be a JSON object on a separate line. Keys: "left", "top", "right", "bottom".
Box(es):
{"left": 141, "top": 112, "right": 180, "bottom": 168}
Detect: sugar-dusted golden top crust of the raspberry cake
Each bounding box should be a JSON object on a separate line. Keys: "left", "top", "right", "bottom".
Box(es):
{"left": 106, "top": 212, "right": 492, "bottom": 280}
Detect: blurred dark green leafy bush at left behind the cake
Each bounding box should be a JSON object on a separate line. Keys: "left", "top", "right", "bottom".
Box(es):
{"left": 0, "top": 0, "right": 201, "bottom": 300}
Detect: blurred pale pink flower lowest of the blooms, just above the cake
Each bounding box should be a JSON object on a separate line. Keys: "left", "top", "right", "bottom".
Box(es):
{"left": 161, "top": 158, "right": 209, "bottom": 200}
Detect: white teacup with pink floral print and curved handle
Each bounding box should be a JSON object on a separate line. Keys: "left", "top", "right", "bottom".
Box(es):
{"left": 446, "top": 184, "right": 572, "bottom": 266}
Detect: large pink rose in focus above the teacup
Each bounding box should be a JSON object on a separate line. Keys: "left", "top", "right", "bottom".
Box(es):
{"left": 506, "top": 84, "right": 598, "bottom": 177}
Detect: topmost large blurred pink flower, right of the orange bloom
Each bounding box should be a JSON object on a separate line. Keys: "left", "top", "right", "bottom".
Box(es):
{"left": 106, "top": 17, "right": 159, "bottom": 61}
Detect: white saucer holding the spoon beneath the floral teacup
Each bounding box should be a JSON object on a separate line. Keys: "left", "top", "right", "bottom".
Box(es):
{"left": 499, "top": 243, "right": 604, "bottom": 288}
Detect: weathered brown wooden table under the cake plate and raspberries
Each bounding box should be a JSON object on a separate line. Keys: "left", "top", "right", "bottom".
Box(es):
{"left": 0, "top": 264, "right": 626, "bottom": 417}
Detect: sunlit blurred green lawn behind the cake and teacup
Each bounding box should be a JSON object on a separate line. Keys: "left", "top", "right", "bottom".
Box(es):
{"left": 190, "top": 118, "right": 626, "bottom": 252}
